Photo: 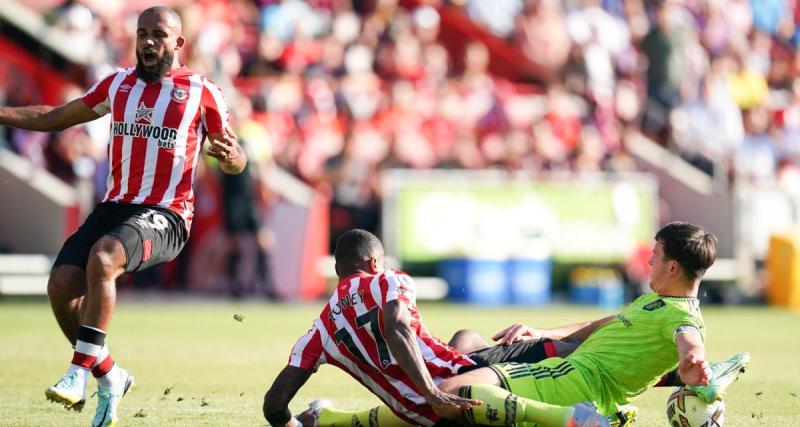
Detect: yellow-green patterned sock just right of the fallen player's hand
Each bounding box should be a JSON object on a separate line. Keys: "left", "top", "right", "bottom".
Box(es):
{"left": 458, "top": 385, "right": 573, "bottom": 427}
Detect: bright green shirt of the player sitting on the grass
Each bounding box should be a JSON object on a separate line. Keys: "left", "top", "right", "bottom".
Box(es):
{"left": 567, "top": 292, "right": 705, "bottom": 414}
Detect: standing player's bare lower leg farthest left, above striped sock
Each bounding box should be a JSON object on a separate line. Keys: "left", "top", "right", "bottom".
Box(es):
{"left": 47, "top": 265, "right": 86, "bottom": 345}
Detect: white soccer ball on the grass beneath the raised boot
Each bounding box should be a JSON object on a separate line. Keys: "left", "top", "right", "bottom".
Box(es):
{"left": 667, "top": 387, "right": 725, "bottom": 427}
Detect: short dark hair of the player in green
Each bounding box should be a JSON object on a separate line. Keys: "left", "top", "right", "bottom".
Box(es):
{"left": 656, "top": 221, "right": 717, "bottom": 280}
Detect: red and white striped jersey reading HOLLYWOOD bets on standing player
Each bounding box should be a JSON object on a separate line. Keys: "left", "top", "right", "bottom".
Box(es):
{"left": 82, "top": 67, "right": 228, "bottom": 230}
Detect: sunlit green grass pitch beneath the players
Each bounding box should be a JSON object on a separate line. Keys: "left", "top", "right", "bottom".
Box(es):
{"left": 0, "top": 298, "right": 800, "bottom": 426}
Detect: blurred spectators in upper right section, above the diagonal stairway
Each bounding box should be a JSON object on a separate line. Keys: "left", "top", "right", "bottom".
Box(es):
{"left": 459, "top": 0, "right": 800, "bottom": 193}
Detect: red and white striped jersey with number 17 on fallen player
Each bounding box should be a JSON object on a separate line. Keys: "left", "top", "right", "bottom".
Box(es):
{"left": 289, "top": 270, "right": 475, "bottom": 426}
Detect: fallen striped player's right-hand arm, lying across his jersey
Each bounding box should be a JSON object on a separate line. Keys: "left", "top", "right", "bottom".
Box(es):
{"left": 383, "top": 300, "right": 480, "bottom": 419}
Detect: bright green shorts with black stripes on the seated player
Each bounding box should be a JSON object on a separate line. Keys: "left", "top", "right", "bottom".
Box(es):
{"left": 489, "top": 357, "right": 594, "bottom": 406}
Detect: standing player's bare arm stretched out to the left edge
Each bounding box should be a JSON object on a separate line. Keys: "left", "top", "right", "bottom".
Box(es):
{"left": 0, "top": 99, "right": 100, "bottom": 132}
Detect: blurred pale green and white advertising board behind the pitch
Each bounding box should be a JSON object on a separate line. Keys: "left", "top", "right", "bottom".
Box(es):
{"left": 383, "top": 170, "right": 657, "bottom": 263}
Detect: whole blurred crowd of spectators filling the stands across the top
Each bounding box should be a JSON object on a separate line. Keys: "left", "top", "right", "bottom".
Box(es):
{"left": 4, "top": 0, "right": 800, "bottom": 237}
